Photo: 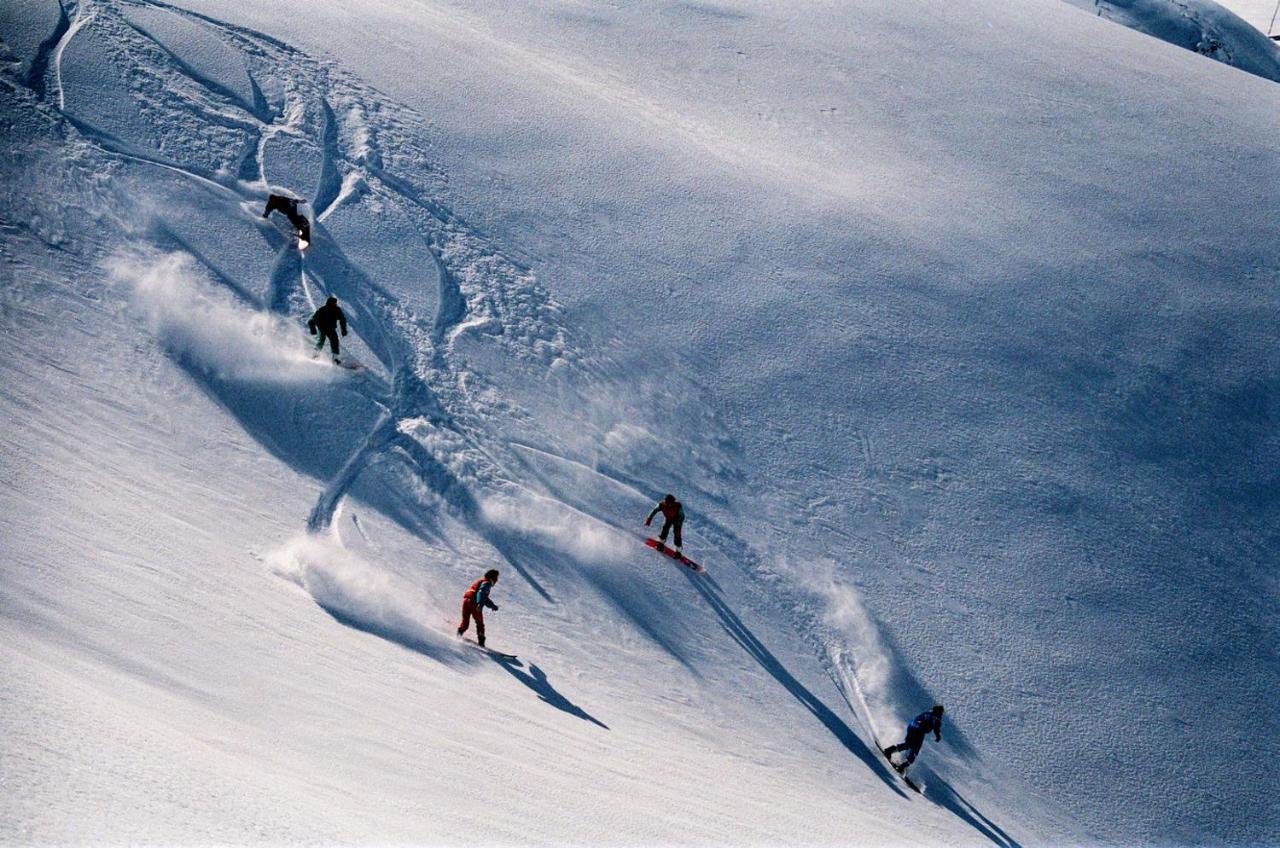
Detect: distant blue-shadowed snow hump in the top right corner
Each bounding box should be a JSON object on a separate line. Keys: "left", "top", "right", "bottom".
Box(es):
{"left": 1068, "top": 0, "right": 1280, "bottom": 82}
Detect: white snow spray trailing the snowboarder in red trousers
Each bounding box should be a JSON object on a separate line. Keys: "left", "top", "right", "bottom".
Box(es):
{"left": 266, "top": 534, "right": 465, "bottom": 662}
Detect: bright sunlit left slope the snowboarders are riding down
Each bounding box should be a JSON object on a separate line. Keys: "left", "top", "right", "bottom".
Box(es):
{"left": 4, "top": 6, "right": 1049, "bottom": 843}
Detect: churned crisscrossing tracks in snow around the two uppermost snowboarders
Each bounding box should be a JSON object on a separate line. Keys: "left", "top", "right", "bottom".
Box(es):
{"left": 13, "top": 1, "right": 614, "bottom": 630}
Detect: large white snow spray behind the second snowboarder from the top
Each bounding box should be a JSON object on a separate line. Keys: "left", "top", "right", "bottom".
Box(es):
{"left": 104, "top": 251, "right": 334, "bottom": 380}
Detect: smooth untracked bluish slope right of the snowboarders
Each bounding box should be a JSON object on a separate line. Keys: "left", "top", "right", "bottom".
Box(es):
{"left": 154, "top": 4, "right": 1276, "bottom": 845}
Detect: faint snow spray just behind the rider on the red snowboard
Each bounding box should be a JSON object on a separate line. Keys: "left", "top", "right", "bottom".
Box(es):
{"left": 481, "top": 493, "right": 635, "bottom": 562}
